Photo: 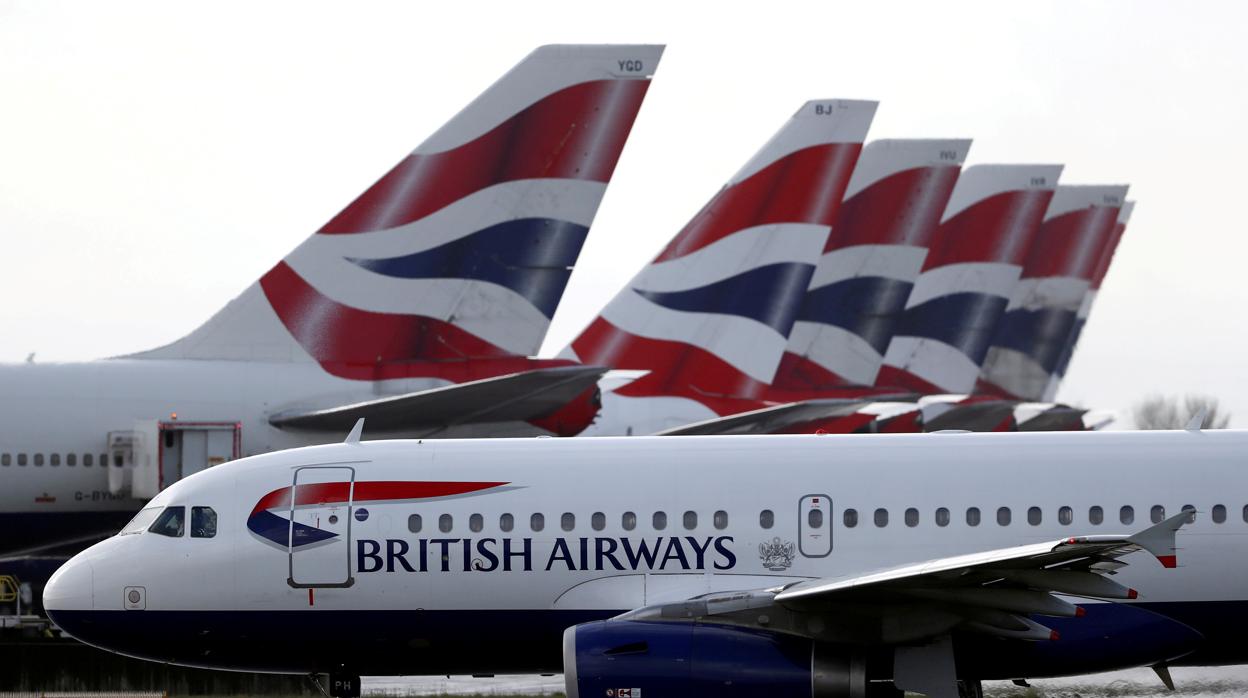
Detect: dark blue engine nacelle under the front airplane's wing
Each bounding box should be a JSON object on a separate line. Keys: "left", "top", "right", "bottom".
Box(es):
{"left": 563, "top": 621, "right": 875, "bottom": 698}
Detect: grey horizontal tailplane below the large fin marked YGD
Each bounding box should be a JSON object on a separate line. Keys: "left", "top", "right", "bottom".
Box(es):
{"left": 268, "top": 366, "right": 607, "bottom": 432}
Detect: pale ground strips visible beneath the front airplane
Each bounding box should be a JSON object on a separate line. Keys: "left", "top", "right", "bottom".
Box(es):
{"left": 363, "top": 667, "right": 1248, "bottom": 698}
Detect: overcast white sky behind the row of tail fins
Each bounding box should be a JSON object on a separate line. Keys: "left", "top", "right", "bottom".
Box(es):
{"left": 0, "top": 0, "right": 1248, "bottom": 426}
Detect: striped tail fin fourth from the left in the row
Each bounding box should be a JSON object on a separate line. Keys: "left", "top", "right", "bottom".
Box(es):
{"left": 875, "top": 165, "right": 1062, "bottom": 393}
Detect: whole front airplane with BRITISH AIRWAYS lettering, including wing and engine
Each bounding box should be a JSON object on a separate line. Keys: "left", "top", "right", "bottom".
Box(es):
{"left": 44, "top": 423, "right": 1248, "bottom": 698}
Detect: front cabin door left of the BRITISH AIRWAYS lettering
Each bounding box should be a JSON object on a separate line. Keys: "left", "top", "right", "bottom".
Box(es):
{"left": 287, "top": 466, "right": 356, "bottom": 588}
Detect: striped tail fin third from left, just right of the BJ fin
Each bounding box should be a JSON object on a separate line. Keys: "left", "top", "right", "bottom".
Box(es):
{"left": 774, "top": 140, "right": 971, "bottom": 391}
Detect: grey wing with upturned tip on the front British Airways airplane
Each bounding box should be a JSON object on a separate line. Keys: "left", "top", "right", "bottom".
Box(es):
{"left": 620, "top": 511, "right": 1194, "bottom": 644}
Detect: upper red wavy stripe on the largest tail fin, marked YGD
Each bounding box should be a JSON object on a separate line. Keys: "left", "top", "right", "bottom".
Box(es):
{"left": 318, "top": 80, "right": 650, "bottom": 235}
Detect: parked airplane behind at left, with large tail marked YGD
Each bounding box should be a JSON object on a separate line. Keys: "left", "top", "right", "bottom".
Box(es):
{"left": 0, "top": 45, "right": 663, "bottom": 554}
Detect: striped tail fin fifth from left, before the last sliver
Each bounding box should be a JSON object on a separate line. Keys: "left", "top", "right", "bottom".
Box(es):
{"left": 977, "top": 185, "right": 1127, "bottom": 401}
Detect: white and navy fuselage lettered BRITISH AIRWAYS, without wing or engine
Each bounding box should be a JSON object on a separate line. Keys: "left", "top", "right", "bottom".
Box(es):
{"left": 44, "top": 432, "right": 1248, "bottom": 678}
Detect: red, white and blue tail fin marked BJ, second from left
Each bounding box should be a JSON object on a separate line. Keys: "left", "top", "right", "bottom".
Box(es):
{"left": 564, "top": 100, "right": 876, "bottom": 413}
